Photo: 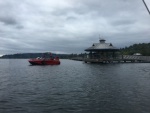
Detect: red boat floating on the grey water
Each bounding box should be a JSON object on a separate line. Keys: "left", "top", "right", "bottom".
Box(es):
{"left": 28, "top": 54, "right": 60, "bottom": 65}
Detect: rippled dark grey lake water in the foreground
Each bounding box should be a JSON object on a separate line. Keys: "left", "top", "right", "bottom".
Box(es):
{"left": 0, "top": 59, "right": 150, "bottom": 113}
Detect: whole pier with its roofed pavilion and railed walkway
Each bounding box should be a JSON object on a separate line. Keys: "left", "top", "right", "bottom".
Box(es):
{"left": 72, "top": 39, "right": 150, "bottom": 63}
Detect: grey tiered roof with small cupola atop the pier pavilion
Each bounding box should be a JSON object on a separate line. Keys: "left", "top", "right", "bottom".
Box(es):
{"left": 85, "top": 39, "right": 119, "bottom": 51}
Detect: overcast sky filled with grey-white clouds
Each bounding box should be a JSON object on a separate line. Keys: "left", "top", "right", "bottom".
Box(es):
{"left": 0, "top": 0, "right": 150, "bottom": 55}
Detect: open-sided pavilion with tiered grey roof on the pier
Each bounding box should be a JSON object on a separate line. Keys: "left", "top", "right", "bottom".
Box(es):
{"left": 85, "top": 39, "right": 119, "bottom": 62}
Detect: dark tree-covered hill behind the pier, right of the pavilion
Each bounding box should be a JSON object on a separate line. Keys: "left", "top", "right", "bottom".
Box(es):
{"left": 120, "top": 43, "right": 150, "bottom": 56}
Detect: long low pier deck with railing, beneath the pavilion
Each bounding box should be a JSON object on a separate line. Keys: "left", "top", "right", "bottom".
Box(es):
{"left": 72, "top": 55, "right": 150, "bottom": 63}
